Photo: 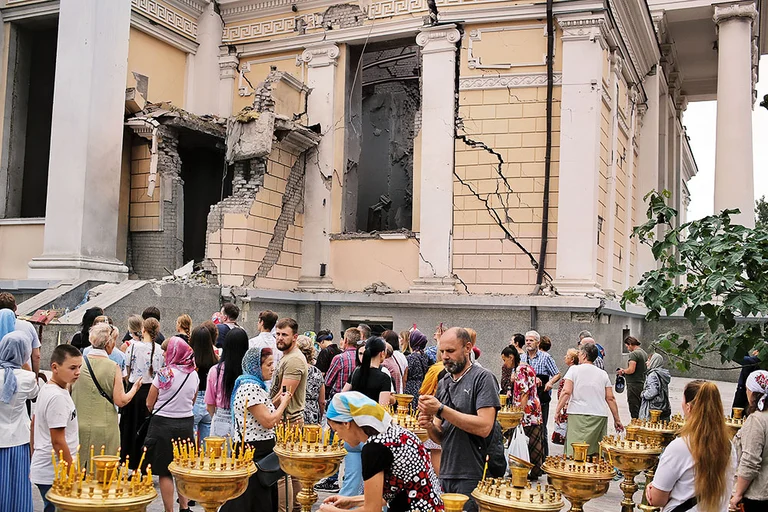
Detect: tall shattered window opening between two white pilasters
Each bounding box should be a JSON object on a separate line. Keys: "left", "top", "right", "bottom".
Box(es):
{"left": 344, "top": 41, "right": 421, "bottom": 232}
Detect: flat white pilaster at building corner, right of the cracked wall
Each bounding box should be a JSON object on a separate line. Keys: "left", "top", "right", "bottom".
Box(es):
{"left": 554, "top": 16, "right": 606, "bottom": 295}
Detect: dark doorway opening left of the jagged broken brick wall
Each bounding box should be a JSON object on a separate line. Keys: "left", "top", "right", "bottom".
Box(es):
{"left": 179, "top": 131, "right": 233, "bottom": 263}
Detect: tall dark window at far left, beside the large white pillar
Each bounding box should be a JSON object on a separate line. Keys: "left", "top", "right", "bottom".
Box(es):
{"left": 0, "top": 18, "right": 58, "bottom": 217}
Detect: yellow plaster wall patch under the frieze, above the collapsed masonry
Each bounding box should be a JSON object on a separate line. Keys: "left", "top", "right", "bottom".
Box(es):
{"left": 232, "top": 51, "right": 305, "bottom": 115}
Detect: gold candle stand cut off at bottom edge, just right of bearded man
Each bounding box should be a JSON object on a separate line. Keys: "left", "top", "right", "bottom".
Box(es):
{"left": 472, "top": 466, "right": 564, "bottom": 512}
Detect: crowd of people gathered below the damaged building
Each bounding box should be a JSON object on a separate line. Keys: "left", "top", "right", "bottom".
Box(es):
{"left": 0, "top": 293, "right": 768, "bottom": 512}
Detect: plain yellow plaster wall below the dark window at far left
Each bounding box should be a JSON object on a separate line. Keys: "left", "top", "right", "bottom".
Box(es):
{"left": 0, "top": 221, "right": 45, "bottom": 279}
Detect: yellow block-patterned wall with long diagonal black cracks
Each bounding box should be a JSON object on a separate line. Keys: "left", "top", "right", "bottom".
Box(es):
{"left": 453, "top": 24, "right": 561, "bottom": 294}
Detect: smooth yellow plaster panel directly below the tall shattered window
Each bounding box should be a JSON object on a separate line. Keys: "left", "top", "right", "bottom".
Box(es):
{"left": 330, "top": 239, "right": 419, "bottom": 292}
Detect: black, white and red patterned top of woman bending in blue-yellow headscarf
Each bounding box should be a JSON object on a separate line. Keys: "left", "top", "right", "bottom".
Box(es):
{"left": 362, "top": 422, "right": 445, "bottom": 512}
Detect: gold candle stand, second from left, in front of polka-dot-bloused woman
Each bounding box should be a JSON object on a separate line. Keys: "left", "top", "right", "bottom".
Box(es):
{"left": 168, "top": 437, "right": 256, "bottom": 512}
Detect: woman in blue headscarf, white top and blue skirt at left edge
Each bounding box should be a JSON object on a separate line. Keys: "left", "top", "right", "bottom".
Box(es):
{"left": 0, "top": 330, "right": 38, "bottom": 512}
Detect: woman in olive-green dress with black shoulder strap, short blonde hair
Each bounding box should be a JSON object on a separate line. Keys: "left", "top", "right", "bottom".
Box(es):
{"left": 72, "top": 323, "right": 141, "bottom": 456}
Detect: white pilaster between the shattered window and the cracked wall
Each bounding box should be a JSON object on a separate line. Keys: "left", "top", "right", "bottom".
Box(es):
{"left": 411, "top": 25, "right": 461, "bottom": 293}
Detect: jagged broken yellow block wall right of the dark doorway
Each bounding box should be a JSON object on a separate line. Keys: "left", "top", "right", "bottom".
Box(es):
{"left": 212, "top": 145, "right": 304, "bottom": 290}
